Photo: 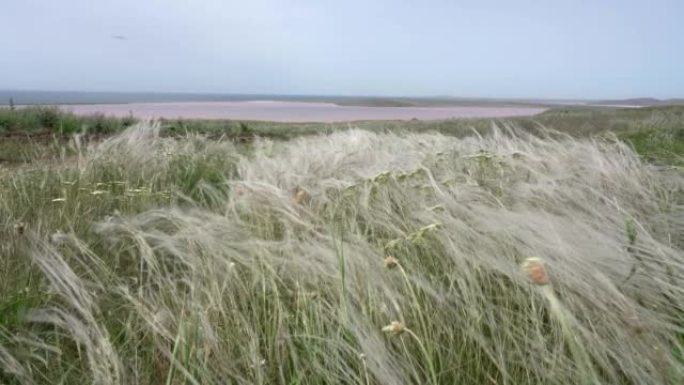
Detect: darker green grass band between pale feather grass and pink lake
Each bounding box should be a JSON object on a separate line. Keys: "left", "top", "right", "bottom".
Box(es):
{"left": 0, "top": 105, "right": 684, "bottom": 166}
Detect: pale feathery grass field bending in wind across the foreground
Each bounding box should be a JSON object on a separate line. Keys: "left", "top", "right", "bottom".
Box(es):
{"left": 0, "top": 125, "right": 684, "bottom": 384}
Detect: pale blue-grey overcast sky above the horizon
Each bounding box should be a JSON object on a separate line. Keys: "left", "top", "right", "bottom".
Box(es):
{"left": 0, "top": 0, "right": 684, "bottom": 98}
